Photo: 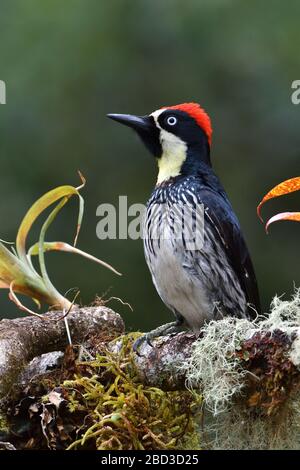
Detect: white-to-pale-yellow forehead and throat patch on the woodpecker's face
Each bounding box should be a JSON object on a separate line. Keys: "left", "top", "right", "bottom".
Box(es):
{"left": 150, "top": 109, "right": 187, "bottom": 184}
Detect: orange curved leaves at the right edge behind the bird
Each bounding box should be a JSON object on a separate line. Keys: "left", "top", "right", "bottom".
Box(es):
{"left": 257, "top": 176, "right": 300, "bottom": 232}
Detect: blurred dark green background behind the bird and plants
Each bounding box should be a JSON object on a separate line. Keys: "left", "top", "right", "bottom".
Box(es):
{"left": 0, "top": 0, "right": 300, "bottom": 330}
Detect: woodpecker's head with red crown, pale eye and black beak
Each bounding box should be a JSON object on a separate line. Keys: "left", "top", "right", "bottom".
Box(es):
{"left": 108, "top": 103, "right": 212, "bottom": 182}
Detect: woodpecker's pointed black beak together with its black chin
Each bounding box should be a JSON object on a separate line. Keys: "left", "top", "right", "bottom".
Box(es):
{"left": 107, "top": 114, "right": 161, "bottom": 157}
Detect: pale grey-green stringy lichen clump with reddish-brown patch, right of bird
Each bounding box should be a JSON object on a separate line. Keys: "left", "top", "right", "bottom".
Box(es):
{"left": 183, "top": 289, "right": 300, "bottom": 449}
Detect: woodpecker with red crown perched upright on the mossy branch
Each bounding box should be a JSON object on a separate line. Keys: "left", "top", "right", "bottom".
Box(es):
{"left": 107, "top": 102, "right": 261, "bottom": 351}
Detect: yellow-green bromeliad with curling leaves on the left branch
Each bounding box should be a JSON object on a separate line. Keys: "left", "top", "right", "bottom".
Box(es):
{"left": 0, "top": 173, "right": 120, "bottom": 317}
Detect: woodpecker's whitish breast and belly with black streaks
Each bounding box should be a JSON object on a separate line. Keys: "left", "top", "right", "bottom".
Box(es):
{"left": 144, "top": 174, "right": 258, "bottom": 330}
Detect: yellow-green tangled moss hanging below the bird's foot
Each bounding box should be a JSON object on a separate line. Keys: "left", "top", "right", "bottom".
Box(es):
{"left": 63, "top": 335, "right": 201, "bottom": 450}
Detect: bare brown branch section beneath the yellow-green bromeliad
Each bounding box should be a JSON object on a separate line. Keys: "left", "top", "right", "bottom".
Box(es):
{"left": 0, "top": 306, "right": 124, "bottom": 398}
